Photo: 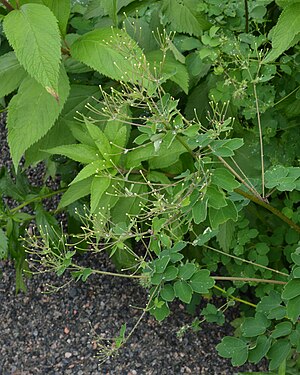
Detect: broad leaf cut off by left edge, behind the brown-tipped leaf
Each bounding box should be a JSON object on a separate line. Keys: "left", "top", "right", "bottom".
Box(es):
{"left": 0, "top": 52, "right": 27, "bottom": 98}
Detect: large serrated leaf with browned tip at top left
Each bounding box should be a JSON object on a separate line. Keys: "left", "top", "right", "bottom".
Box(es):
{"left": 3, "top": 4, "right": 64, "bottom": 97}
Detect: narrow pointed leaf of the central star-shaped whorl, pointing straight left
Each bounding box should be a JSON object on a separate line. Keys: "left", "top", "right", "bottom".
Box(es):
{"left": 45, "top": 143, "right": 99, "bottom": 164}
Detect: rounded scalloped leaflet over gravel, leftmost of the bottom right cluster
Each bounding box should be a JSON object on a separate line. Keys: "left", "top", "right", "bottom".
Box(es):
{"left": 216, "top": 337, "right": 248, "bottom": 366}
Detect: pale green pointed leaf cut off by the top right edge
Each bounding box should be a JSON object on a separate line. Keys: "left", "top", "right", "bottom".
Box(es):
{"left": 264, "top": 3, "right": 300, "bottom": 63}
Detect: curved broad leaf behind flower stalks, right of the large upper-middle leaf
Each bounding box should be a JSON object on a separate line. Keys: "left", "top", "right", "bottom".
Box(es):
{"left": 146, "top": 50, "right": 189, "bottom": 94}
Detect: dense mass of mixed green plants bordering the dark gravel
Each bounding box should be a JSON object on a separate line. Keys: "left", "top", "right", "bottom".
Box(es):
{"left": 0, "top": 0, "right": 300, "bottom": 374}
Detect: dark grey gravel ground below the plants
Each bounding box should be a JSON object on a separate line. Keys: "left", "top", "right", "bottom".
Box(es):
{"left": 0, "top": 116, "right": 268, "bottom": 375}
